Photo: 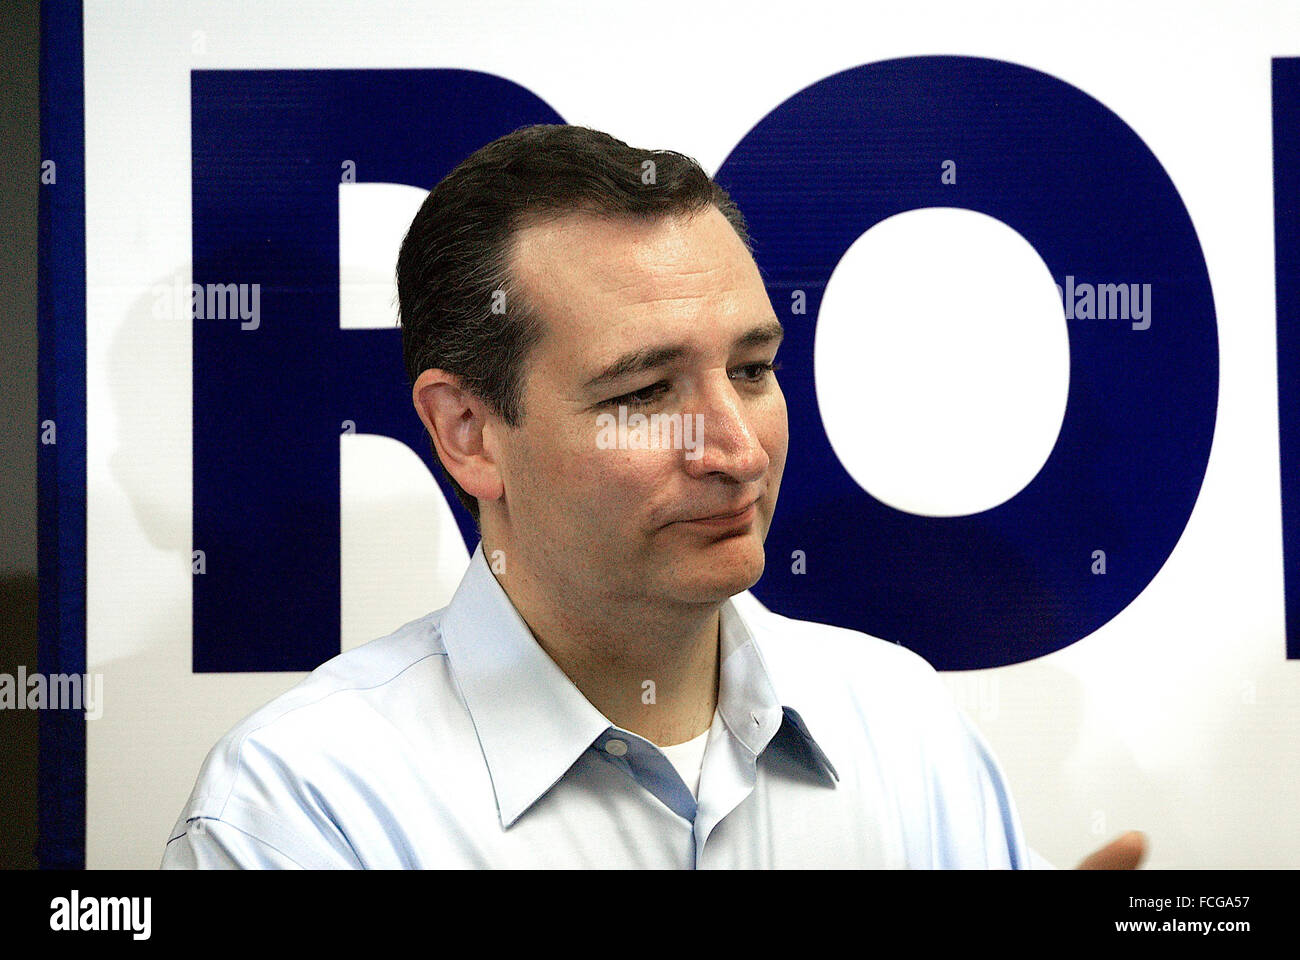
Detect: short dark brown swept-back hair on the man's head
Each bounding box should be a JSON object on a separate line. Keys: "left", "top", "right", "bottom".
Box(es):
{"left": 398, "top": 124, "right": 751, "bottom": 523}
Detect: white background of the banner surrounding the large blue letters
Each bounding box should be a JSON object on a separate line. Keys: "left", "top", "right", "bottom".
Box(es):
{"left": 86, "top": 0, "right": 1300, "bottom": 868}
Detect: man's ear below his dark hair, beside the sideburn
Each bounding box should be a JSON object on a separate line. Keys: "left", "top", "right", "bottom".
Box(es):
{"left": 411, "top": 369, "right": 504, "bottom": 500}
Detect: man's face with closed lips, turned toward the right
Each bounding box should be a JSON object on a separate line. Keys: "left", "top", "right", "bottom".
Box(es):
{"left": 485, "top": 207, "right": 788, "bottom": 604}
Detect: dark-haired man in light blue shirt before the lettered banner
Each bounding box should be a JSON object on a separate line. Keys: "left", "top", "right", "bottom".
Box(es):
{"left": 163, "top": 126, "right": 1138, "bottom": 868}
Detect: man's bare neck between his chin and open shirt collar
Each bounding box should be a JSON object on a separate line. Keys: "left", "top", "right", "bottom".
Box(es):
{"left": 484, "top": 535, "right": 722, "bottom": 747}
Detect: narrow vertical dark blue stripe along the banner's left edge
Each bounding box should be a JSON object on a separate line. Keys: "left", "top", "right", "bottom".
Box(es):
{"left": 36, "top": 0, "right": 86, "bottom": 869}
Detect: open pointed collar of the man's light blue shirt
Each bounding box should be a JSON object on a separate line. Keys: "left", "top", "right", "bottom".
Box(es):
{"left": 441, "top": 541, "right": 835, "bottom": 829}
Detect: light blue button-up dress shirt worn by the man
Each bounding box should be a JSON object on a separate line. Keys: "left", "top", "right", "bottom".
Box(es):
{"left": 163, "top": 544, "right": 1035, "bottom": 869}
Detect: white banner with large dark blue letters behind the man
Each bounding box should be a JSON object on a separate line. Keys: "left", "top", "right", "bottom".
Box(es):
{"left": 38, "top": 0, "right": 1300, "bottom": 868}
